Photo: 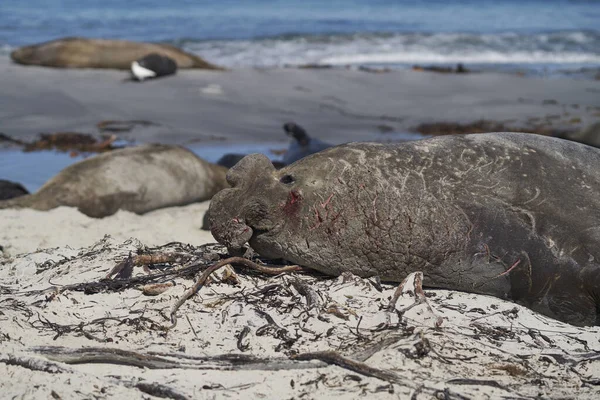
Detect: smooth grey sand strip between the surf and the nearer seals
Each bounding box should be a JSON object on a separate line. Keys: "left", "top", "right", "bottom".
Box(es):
{"left": 0, "top": 57, "right": 600, "bottom": 144}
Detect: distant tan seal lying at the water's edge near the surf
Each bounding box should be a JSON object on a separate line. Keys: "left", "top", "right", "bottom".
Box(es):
{"left": 10, "top": 37, "right": 221, "bottom": 69}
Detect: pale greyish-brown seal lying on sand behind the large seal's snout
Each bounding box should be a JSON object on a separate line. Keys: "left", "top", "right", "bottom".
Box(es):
{"left": 0, "top": 145, "right": 228, "bottom": 218}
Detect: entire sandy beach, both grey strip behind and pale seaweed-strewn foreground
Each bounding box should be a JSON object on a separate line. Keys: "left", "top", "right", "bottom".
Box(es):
{"left": 0, "top": 54, "right": 600, "bottom": 399}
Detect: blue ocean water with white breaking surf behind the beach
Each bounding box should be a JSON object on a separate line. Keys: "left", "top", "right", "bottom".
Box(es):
{"left": 0, "top": 0, "right": 600, "bottom": 76}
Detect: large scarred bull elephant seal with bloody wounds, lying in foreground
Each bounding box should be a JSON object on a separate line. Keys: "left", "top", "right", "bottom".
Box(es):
{"left": 209, "top": 133, "right": 600, "bottom": 325}
